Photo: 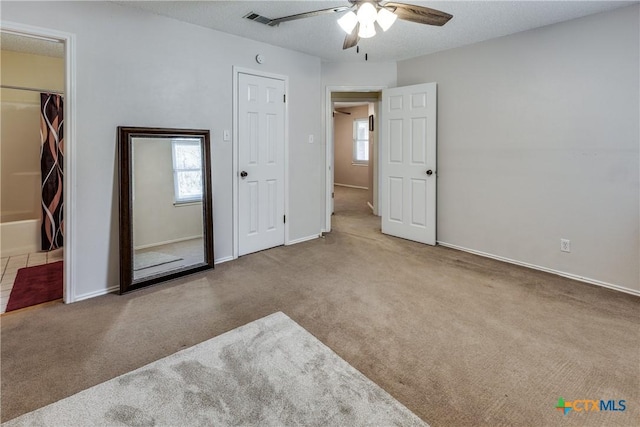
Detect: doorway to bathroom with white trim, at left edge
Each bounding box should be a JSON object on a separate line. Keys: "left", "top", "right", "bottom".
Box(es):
{"left": 0, "top": 22, "right": 75, "bottom": 313}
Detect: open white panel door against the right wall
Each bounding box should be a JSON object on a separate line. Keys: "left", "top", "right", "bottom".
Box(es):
{"left": 380, "top": 83, "right": 437, "bottom": 245}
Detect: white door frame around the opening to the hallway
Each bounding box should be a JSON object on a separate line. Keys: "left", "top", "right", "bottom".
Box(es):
{"left": 322, "top": 86, "right": 387, "bottom": 233}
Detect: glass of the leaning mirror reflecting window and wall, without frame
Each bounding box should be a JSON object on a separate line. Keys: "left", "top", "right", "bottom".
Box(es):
{"left": 131, "top": 137, "right": 205, "bottom": 281}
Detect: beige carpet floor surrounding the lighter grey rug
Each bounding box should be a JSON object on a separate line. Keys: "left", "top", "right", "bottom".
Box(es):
{"left": 1, "top": 188, "right": 640, "bottom": 426}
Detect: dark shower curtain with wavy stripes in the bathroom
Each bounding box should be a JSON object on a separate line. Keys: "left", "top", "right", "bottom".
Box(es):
{"left": 40, "top": 93, "right": 64, "bottom": 251}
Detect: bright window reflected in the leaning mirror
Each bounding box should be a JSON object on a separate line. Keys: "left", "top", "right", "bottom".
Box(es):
{"left": 171, "top": 138, "right": 202, "bottom": 204}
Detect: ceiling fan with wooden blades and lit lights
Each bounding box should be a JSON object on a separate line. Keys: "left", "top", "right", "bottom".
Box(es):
{"left": 244, "top": 0, "right": 453, "bottom": 49}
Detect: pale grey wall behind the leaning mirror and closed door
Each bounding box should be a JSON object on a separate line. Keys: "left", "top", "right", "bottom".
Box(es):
{"left": 2, "top": 1, "right": 324, "bottom": 298}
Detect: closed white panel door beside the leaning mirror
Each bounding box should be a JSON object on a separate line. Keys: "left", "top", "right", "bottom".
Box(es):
{"left": 236, "top": 73, "right": 285, "bottom": 255}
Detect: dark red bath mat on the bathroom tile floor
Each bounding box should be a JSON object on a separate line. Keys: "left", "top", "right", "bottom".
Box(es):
{"left": 5, "top": 261, "right": 64, "bottom": 312}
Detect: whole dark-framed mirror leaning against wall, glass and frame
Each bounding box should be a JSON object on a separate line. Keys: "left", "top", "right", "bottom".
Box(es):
{"left": 118, "top": 126, "right": 213, "bottom": 294}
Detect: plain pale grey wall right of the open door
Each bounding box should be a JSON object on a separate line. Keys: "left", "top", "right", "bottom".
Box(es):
{"left": 398, "top": 5, "right": 640, "bottom": 292}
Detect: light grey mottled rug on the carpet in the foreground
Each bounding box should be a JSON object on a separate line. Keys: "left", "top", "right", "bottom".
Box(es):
{"left": 3, "top": 312, "right": 428, "bottom": 427}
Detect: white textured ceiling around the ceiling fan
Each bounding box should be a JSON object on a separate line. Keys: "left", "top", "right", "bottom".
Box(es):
{"left": 115, "top": 0, "right": 638, "bottom": 62}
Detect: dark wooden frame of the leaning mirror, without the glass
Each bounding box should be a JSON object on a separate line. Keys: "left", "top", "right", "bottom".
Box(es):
{"left": 118, "top": 126, "right": 214, "bottom": 294}
